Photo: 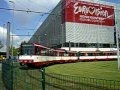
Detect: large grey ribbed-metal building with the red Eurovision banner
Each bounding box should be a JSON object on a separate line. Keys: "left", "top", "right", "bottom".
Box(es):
{"left": 30, "top": 0, "right": 120, "bottom": 51}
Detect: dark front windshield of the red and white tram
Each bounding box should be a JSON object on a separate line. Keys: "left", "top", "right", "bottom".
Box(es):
{"left": 21, "top": 44, "right": 34, "bottom": 55}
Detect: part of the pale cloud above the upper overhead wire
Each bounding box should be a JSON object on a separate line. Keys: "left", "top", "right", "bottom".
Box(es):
{"left": 6, "top": 0, "right": 60, "bottom": 12}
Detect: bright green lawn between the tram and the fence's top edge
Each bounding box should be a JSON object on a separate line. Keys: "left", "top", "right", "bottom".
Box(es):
{"left": 46, "top": 61, "right": 120, "bottom": 81}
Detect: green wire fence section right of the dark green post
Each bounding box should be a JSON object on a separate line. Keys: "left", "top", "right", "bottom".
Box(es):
{"left": 46, "top": 74, "right": 120, "bottom": 90}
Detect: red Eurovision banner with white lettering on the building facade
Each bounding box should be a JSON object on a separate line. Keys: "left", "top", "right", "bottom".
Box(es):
{"left": 65, "top": 0, "right": 114, "bottom": 26}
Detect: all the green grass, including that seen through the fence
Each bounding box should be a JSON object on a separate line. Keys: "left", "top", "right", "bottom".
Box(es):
{"left": 1, "top": 61, "right": 120, "bottom": 90}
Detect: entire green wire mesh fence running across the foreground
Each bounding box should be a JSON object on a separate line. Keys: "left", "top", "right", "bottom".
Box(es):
{"left": 2, "top": 61, "right": 120, "bottom": 90}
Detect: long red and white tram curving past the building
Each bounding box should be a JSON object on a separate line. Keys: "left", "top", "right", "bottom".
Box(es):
{"left": 19, "top": 43, "right": 117, "bottom": 67}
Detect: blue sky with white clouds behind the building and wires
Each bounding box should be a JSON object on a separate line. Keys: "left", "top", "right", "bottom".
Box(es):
{"left": 0, "top": 0, "right": 120, "bottom": 51}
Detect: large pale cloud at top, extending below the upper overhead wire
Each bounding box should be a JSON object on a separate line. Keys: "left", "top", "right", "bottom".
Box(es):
{"left": 5, "top": 0, "right": 60, "bottom": 25}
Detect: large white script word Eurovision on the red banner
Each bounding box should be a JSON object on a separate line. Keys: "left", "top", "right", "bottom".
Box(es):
{"left": 74, "top": 2, "right": 111, "bottom": 18}
